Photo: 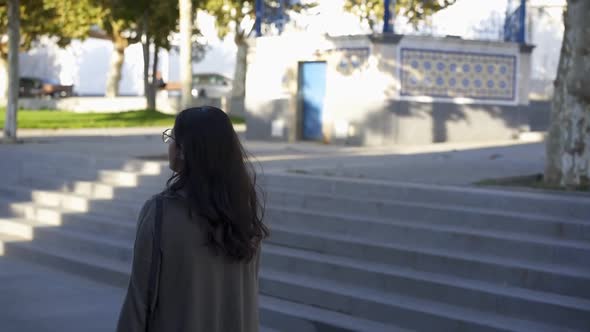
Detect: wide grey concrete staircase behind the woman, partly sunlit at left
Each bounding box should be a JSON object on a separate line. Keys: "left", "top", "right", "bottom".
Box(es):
{"left": 0, "top": 161, "right": 590, "bottom": 332}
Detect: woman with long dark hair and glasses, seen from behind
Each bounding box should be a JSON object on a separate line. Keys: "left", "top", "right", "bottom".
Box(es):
{"left": 117, "top": 107, "right": 269, "bottom": 332}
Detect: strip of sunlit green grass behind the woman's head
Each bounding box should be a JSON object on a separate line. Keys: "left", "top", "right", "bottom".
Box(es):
{"left": 0, "top": 108, "right": 244, "bottom": 129}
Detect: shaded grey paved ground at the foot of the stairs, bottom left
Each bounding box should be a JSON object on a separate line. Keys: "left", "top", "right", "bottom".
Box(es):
{"left": 0, "top": 256, "right": 124, "bottom": 332}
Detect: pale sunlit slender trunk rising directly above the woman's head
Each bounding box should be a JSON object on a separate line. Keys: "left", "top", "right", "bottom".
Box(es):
{"left": 179, "top": 0, "right": 193, "bottom": 109}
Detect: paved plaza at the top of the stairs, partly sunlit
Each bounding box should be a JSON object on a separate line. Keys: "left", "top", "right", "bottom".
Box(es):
{"left": 0, "top": 128, "right": 545, "bottom": 185}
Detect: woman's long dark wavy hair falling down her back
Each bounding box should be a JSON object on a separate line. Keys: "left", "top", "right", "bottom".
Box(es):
{"left": 167, "top": 106, "right": 269, "bottom": 261}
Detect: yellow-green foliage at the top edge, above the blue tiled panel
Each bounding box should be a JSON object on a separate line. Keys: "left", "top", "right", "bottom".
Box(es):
{"left": 344, "top": 0, "right": 456, "bottom": 29}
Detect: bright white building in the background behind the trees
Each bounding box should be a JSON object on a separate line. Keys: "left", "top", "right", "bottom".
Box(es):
{"left": 0, "top": 0, "right": 565, "bottom": 99}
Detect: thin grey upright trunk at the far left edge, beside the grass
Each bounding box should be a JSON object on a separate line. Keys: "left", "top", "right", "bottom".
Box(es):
{"left": 4, "top": 0, "right": 20, "bottom": 142}
